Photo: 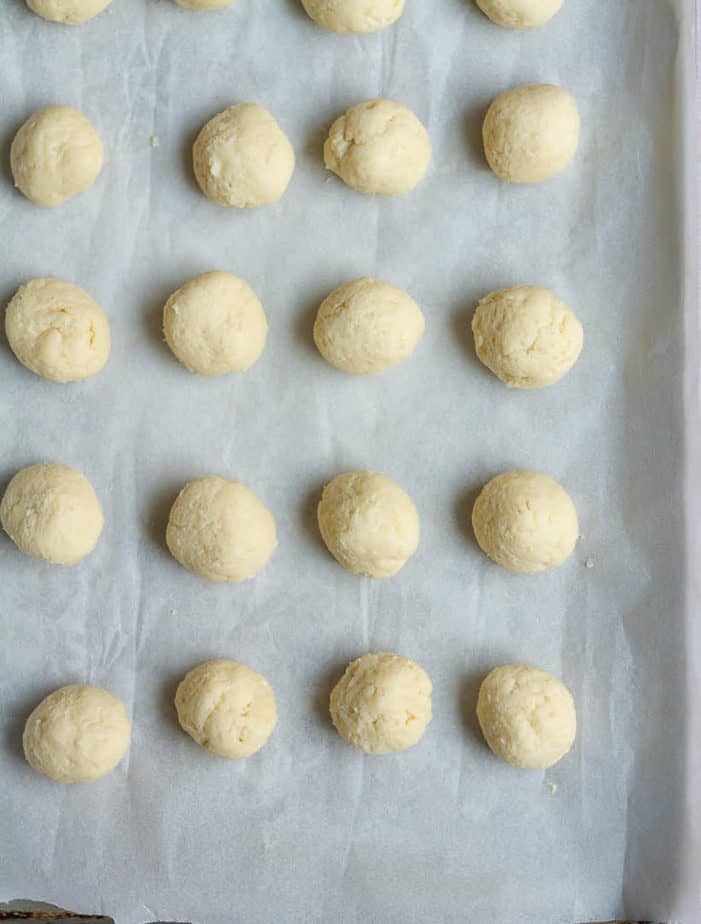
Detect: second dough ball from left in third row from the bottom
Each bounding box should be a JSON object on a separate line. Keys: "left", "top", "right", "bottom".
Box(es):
{"left": 163, "top": 272, "right": 268, "bottom": 375}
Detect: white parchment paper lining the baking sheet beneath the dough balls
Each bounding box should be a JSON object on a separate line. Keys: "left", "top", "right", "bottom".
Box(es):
{"left": 0, "top": 0, "right": 701, "bottom": 924}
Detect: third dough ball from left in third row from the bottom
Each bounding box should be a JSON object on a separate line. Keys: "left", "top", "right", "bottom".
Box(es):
{"left": 314, "top": 278, "right": 425, "bottom": 375}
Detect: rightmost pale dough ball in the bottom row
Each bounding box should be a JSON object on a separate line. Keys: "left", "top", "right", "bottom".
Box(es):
{"left": 477, "top": 664, "right": 577, "bottom": 770}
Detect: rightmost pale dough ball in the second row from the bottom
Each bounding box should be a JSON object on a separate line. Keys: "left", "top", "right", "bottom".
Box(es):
{"left": 472, "top": 472, "right": 579, "bottom": 574}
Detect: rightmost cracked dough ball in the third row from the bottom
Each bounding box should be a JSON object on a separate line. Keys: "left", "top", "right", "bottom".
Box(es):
{"left": 472, "top": 286, "right": 584, "bottom": 388}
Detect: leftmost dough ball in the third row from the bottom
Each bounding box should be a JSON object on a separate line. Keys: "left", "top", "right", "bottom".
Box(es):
{"left": 5, "top": 279, "right": 110, "bottom": 382}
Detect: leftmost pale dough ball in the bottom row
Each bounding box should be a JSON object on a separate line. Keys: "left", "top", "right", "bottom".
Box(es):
{"left": 22, "top": 683, "right": 131, "bottom": 783}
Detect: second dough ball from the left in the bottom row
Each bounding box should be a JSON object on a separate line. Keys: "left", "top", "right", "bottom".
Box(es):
{"left": 175, "top": 659, "right": 277, "bottom": 760}
